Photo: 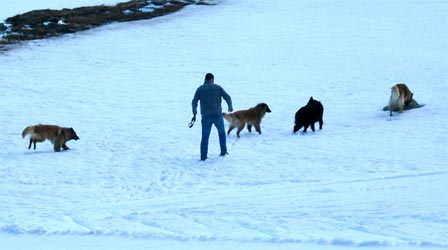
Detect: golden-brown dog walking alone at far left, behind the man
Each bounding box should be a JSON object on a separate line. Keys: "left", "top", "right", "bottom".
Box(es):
{"left": 22, "top": 124, "right": 79, "bottom": 152}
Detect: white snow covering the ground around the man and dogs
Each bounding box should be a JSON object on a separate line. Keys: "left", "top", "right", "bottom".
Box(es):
{"left": 0, "top": 0, "right": 448, "bottom": 250}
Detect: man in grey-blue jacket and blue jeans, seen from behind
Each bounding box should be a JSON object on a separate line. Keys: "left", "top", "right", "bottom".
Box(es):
{"left": 191, "top": 73, "right": 233, "bottom": 161}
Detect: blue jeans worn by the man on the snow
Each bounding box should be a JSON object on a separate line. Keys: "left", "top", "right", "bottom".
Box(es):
{"left": 201, "top": 114, "right": 227, "bottom": 161}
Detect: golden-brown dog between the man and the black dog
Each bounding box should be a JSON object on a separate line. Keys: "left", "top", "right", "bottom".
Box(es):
{"left": 223, "top": 103, "right": 271, "bottom": 137}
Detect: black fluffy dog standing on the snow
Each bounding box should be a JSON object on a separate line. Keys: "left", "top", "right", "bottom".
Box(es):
{"left": 294, "top": 97, "right": 324, "bottom": 133}
